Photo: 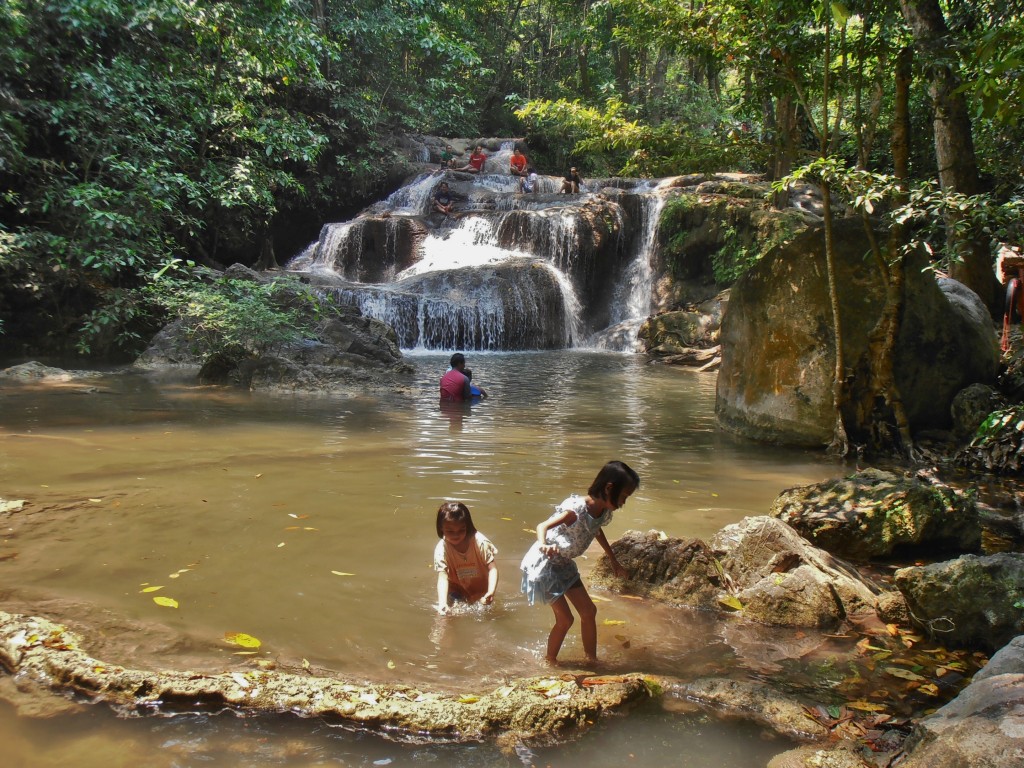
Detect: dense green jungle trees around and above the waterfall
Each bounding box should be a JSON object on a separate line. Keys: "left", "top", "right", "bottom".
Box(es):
{"left": 0, "top": 0, "right": 1024, "bottom": 357}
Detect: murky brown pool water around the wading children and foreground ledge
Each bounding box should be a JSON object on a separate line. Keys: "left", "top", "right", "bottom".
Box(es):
{"left": 0, "top": 351, "right": 847, "bottom": 768}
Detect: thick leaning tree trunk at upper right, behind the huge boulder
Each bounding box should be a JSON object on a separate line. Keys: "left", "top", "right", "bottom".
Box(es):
{"left": 900, "top": 0, "right": 998, "bottom": 314}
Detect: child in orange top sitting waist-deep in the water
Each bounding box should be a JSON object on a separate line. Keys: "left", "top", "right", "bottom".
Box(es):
{"left": 434, "top": 502, "right": 498, "bottom": 614}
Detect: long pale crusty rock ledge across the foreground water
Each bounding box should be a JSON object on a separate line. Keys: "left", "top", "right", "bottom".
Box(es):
{"left": 0, "top": 611, "right": 659, "bottom": 748}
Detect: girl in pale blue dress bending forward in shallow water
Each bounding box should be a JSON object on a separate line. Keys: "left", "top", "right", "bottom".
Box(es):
{"left": 521, "top": 462, "right": 640, "bottom": 664}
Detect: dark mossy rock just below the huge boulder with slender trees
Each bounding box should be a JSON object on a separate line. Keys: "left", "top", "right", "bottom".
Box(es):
{"left": 768, "top": 469, "right": 981, "bottom": 560}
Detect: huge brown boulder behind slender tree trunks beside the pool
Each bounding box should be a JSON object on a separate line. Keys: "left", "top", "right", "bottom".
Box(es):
{"left": 716, "top": 219, "right": 999, "bottom": 446}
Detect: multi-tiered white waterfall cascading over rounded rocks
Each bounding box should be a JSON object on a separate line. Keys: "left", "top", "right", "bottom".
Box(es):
{"left": 288, "top": 145, "right": 663, "bottom": 350}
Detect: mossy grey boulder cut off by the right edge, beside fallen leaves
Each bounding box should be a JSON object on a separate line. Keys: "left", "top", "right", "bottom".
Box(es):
{"left": 894, "top": 552, "right": 1024, "bottom": 651}
